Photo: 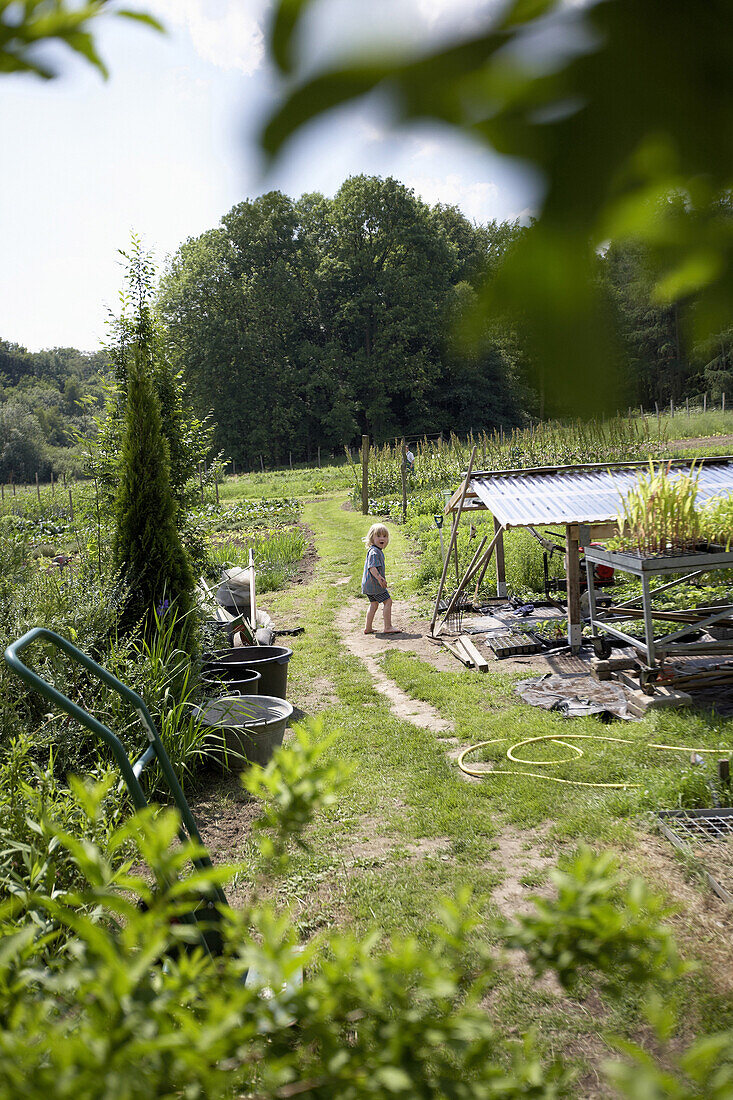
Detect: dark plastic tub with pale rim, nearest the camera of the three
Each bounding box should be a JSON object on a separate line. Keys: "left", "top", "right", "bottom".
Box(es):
{"left": 196, "top": 695, "right": 293, "bottom": 770}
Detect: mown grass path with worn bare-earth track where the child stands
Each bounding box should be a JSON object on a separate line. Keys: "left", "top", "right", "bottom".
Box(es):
{"left": 232, "top": 496, "right": 733, "bottom": 1082}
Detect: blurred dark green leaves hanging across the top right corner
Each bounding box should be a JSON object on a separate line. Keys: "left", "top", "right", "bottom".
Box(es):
{"left": 262, "top": 0, "right": 733, "bottom": 414}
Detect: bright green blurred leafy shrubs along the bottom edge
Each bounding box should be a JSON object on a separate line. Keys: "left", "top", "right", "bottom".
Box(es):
{"left": 0, "top": 732, "right": 733, "bottom": 1100}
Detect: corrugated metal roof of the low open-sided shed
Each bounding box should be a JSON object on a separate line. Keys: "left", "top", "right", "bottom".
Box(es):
{"left": 467, "top": 461, "right": 733, "bottom": 527}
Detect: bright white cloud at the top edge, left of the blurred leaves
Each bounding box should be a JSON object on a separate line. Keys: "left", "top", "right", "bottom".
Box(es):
{"left": 147, "top": 0, "right": 269, "bottom": 76}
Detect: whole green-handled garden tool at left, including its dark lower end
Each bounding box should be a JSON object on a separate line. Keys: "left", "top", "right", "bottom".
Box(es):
{"left": 4, "top": 627, "right": 227, "bottom": 955}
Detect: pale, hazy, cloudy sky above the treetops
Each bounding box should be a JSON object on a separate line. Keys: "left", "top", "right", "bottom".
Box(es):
{"left": 0, "top": 0, "right": 537, "bottom": 351}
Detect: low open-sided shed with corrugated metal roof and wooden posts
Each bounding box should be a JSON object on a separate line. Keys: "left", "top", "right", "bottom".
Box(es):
{"left": 434, "top": 455, "right": 733, "bottom": 651}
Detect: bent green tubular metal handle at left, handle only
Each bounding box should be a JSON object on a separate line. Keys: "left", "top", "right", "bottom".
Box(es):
{"left": 4, "top": 626, "right": 211, "bottom": 867}
